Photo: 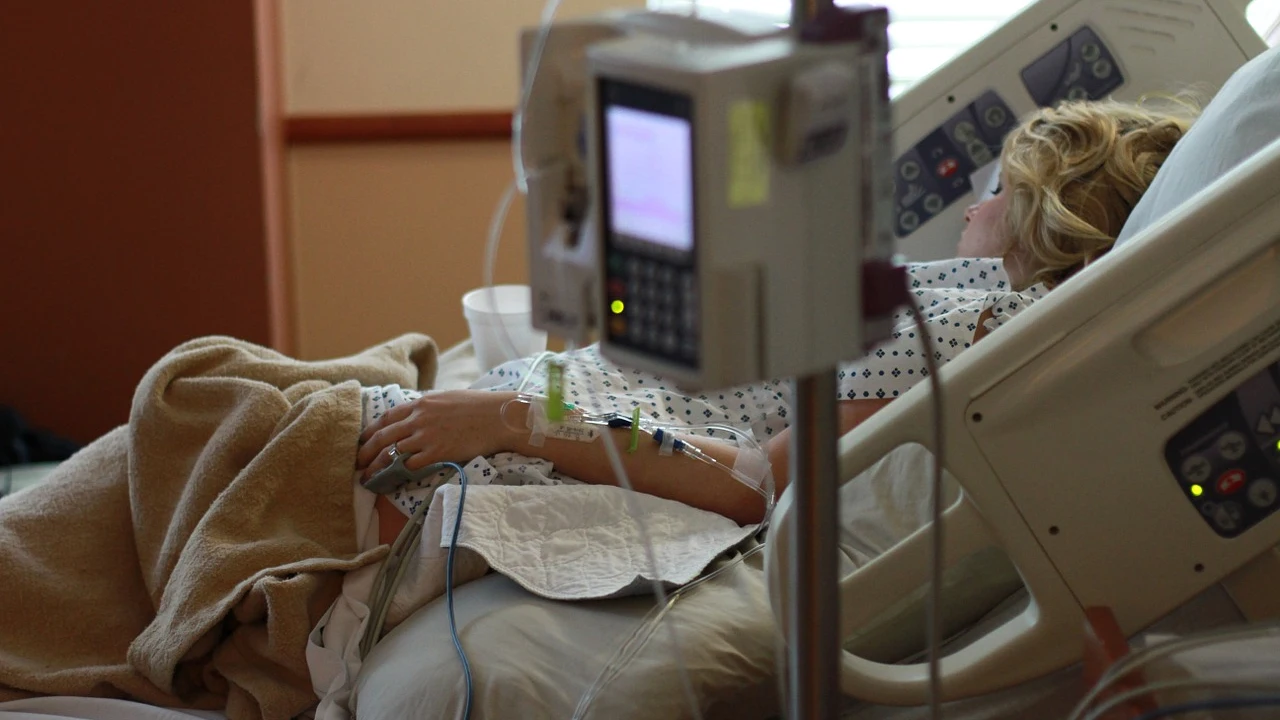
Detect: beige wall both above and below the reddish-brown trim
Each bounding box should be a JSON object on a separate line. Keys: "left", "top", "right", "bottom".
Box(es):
{"left": 282, "top": 0, "right": 643, "bottom": 359}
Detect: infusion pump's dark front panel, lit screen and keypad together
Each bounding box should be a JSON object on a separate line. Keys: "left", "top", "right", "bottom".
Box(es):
{"left": 598, "top": 78, "right": 701, "bottom": 368}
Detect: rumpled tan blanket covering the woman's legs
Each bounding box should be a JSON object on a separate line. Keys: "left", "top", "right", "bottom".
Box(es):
{"left": 0, "top": 336, "right": 436, "bottom": 720}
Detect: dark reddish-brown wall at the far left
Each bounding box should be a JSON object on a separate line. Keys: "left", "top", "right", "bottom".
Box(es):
{"left": 0, "top": 0, "right": 269, "bottom": 441}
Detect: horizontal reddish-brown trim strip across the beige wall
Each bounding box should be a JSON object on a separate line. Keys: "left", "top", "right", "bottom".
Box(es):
{"left": 284, "top": 111, "right": 512, "bottom": 145}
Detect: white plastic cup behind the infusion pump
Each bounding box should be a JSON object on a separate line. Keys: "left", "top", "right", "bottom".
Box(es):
{"left": 462, "top": 284, "right": 547, "bottom": 373}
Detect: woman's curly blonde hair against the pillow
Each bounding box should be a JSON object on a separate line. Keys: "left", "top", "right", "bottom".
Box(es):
{"left": 1001, "top": 99, "right": 1198, "bottom": 287}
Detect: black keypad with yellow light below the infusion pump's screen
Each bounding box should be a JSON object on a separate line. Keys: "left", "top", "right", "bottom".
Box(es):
{"left": 604, "top": 250, "right": 700, "bottom": 368}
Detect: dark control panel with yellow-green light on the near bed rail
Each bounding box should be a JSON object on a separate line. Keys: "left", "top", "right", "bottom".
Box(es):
{"left": 1165, "top": 356, "right": 1280, "bottom": 538}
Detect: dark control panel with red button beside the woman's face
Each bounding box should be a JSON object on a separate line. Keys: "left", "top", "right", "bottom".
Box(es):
{"left": 893, "top": 92, "right": 1018, "bottom": 237}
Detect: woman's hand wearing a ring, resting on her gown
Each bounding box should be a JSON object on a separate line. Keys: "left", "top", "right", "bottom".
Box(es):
{"left": 356, "top": 389, "right": 515, "bottom": 482}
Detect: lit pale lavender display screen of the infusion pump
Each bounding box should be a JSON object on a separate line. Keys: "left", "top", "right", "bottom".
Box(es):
{"left": 604, "top": 105, "right": 694, "bottom": 251}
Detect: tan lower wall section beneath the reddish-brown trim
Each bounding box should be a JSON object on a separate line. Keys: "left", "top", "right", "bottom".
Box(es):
{"left": 289, "top": 142, "right": 526, "bottom": 357}
